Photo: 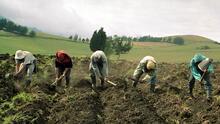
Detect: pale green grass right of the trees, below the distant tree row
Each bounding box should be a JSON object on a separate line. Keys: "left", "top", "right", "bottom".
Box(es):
{"left": 117, "top": 41, "right": 220, "bottom": 62}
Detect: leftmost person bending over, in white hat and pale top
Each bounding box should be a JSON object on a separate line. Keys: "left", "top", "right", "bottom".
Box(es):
{"left": 14, "top": 50, "right": 36, "bottom": 87}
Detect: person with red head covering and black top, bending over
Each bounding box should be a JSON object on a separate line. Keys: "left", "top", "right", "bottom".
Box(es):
{"left": 53, "top": 50, "right": 73, "bottom": 87}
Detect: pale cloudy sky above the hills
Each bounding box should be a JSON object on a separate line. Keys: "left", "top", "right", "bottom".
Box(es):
{"left": 0, "top": 0, "right": 220, "bottom": 41}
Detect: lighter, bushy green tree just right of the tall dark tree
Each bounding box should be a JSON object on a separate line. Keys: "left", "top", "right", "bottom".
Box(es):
{"left": 113, "top": 38, "right": 133, "bottom": 59}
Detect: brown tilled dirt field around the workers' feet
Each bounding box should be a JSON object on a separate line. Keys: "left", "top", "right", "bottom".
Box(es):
{"left": 0, "top": 55, "right": 220, "bottom": 124}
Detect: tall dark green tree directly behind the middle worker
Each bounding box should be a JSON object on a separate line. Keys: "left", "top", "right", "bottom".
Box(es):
{"left": 90, "top": 28, "right": 107, "bottom": 52}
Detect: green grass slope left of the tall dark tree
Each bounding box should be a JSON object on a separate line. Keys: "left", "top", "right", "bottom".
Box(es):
{"left": 0, "top": 32, "right": 91, "bottom": 56}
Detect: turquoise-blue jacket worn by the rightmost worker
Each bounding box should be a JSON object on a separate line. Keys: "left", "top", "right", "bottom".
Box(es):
{"left": 190, "top": 53, "right": 213, "bottom": 80}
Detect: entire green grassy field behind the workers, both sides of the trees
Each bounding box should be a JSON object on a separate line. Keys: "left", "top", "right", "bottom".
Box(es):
{"left": 0, "top": 31, "right": 220, "bottom": 63}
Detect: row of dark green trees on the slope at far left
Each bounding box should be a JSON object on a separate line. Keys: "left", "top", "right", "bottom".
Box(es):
{"left": 0, "top": 18, "right": 36, "bottom": 37}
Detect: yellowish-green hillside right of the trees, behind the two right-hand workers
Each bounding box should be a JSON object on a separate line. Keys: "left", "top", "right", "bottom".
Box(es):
{"left": 121, "top": 36, "right": 220, "bottom": 63}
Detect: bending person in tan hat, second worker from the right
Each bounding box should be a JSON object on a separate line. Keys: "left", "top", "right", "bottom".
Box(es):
{"left": 133, "top": 56, "right": 157, "bottom": 92}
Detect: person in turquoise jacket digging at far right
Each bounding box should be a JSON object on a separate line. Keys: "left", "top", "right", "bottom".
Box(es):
{"left": 188, "top": 53, "right": 213, "bottom": 100}
